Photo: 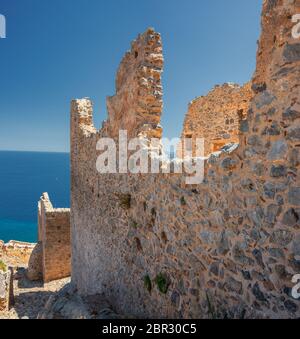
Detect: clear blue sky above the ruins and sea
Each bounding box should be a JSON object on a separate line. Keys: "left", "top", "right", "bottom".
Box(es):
{"left": 0, "top": 0, "right": 262, "bottom": 151}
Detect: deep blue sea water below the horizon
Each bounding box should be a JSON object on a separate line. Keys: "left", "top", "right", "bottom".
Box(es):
{"left": 0, "top": 151, "right": 70, "bottom": 242}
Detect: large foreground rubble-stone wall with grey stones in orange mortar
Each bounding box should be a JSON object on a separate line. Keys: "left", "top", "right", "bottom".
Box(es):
{"left": 71, "top": 0, "right": 300, "bottom": 318}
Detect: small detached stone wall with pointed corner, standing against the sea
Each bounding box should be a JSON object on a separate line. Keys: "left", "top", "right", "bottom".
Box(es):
{"left": 27, "top": 193, "right": 71, "bottom": 282}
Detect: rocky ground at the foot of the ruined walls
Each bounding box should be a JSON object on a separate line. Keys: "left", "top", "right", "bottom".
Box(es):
{"left": 0, "top": 241, "right": 124, "bottom": 319}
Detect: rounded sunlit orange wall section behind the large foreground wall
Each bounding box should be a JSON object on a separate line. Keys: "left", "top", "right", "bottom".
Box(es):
{"left": 177, "top": 83, "right": 253, "bottom": 157}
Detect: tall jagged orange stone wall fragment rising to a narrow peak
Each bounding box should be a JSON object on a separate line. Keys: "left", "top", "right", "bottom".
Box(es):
{"left": 107, "top": 29, "right": 164, "bottom": 138}
